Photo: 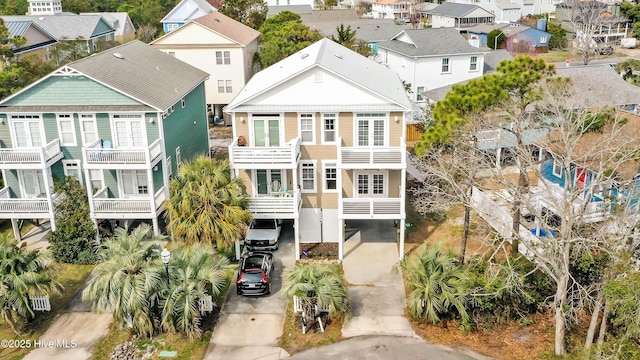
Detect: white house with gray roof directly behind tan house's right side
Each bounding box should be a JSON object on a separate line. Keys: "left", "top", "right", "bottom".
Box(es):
{"left": 378, "top": 28, "right": 485, "bottom": 101}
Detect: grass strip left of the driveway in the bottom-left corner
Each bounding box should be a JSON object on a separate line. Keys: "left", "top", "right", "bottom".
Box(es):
{"left": 0, "top": 263, "right": 93, "bottom": 360}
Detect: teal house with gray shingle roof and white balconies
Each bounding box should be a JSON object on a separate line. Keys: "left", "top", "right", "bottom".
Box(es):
{"left": 0, "top": 41, "right": 209, "bottom": 235}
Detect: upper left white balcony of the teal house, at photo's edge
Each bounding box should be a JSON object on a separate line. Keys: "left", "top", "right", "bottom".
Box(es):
{"left": 0, "top": 139, "right": 63, "bottom": 169}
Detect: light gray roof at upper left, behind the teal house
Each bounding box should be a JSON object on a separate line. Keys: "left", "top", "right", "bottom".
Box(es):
{"left": 2, "top": 13, "right": 115, "bottom": 40}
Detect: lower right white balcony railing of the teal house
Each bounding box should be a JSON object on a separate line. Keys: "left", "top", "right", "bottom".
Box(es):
{"left": 92, "top": 187, "right": 166, "bottom": 215}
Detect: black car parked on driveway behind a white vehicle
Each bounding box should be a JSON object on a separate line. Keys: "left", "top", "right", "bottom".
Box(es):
{"left": 236, "top": 251, "right": 273, "bottom": 295}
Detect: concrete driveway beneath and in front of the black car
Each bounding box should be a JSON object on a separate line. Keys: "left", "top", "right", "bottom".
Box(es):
{"left": 204, "top": 224, "right": 295, "bottom": 360}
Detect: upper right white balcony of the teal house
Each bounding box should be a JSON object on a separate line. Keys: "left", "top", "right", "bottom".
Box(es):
{"left": 82, "top": 139, "right": 163, "bottom": 169}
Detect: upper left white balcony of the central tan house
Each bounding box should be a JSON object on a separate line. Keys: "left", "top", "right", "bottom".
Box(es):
{"left": 229, "top": 137, "right": 300, "bottom": 169}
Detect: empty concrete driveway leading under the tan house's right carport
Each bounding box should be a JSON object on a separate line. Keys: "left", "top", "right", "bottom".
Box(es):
{"left": 342, "top": 220, "right": 416, "bottom": 337}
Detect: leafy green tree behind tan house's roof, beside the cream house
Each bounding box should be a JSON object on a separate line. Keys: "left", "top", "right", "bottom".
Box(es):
{"left": 258, "top": 11, "right": 322, "bottom": 68}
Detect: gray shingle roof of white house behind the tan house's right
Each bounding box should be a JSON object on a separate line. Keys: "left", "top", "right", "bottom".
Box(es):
{"left": 378, "top": 28, "right": 482, "bottom": 56}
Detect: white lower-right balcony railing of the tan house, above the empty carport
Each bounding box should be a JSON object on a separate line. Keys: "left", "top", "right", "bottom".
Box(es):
{"left": 339, "top": 198, "right": 404, "bottom": 219}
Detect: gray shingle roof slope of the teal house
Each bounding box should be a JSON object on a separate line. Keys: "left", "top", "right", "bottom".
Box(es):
{"left": 67, "top": 40, "right": 209, "bottom": 111}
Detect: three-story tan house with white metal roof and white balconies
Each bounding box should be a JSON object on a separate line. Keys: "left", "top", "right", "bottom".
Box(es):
{"left": 225, "top": 38, "right": 411, "bottom": 259}
